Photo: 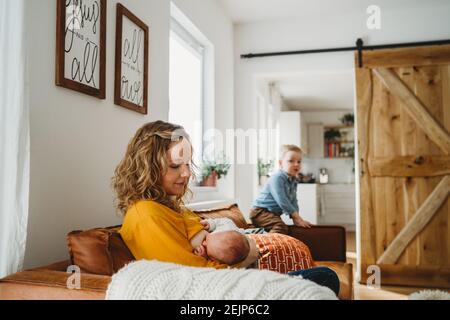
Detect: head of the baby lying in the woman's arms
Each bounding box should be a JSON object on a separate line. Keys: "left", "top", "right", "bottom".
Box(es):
{"left": 204, "top": 231, "right": 250, "bottom": 266}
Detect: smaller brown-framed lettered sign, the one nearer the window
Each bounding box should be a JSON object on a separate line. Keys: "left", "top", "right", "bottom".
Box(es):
{"left": 114, "top": 3, "right": 148, "bottom": 114}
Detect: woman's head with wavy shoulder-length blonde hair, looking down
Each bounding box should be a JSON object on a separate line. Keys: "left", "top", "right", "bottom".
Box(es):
{"left": 113, "top": 121, "right": 193, "bottom": 213}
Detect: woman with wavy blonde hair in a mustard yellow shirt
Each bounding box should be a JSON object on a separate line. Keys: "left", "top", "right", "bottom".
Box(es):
{"left": 113, "top": 121, "right": 339, "bottom": 296}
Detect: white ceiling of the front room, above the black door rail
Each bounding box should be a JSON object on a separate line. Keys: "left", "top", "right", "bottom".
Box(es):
{"left": 217, "top": 0, "right": 448, "bottom": 23}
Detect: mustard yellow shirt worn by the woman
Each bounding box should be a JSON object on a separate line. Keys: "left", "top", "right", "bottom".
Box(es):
{"left": 119, "top": 200, "right": 228, "bottom": 269}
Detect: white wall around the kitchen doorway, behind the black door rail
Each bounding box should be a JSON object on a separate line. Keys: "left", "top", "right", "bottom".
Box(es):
{"left": 235, "top": 2, "right": 450, "bottom": 220}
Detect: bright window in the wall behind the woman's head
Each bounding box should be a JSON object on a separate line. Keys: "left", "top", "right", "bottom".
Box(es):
{"left": 169, "top": 18, "right": 205, "bottom": 165}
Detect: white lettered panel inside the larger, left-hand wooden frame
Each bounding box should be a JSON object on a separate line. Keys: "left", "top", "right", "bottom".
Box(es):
{"left": 64, "top": 0, "right": 100, "bottom": 88}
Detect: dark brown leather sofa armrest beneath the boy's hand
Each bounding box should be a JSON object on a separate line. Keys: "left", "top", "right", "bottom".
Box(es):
{"left": 289, "top": 226, "right": 347, "bottom": 262}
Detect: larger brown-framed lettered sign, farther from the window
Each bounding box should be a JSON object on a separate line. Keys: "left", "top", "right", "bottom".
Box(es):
{"left": 55, "top": 0, "right": 106, "bottom": 99}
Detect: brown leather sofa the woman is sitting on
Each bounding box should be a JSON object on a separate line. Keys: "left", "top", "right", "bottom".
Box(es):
{"left": 0, "top": 205, "right": 353, "bottom": 300}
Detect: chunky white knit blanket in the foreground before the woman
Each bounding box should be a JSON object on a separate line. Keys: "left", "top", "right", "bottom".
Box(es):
{"left": 106, "top": 260, "right": 337, "bottom": 300}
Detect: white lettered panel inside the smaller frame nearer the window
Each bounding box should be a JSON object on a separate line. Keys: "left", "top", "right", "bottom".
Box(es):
{"left": 120, "top": 16, "right": 145, "bottom": 107}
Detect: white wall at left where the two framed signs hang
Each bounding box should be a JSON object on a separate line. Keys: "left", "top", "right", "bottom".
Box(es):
{"left": 24, "top": 0, "right": 234, "bottom": 268}
